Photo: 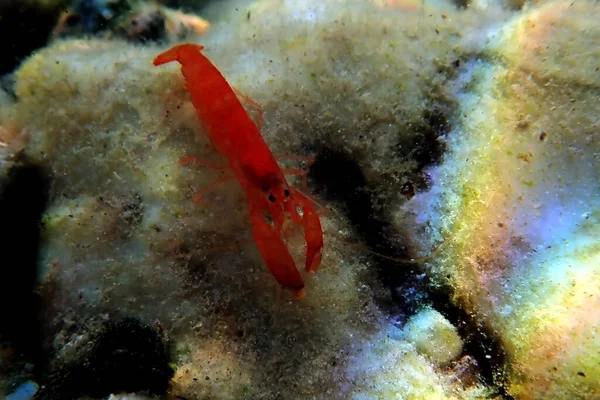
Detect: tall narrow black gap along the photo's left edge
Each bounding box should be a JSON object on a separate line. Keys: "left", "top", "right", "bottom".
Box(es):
{"left": 0, "top": 164, "right": 49, "bottom": 374}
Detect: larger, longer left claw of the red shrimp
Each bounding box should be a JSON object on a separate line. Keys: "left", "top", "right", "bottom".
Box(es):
{"left": 250, "top": 209, "right": 306, "bottom": 299}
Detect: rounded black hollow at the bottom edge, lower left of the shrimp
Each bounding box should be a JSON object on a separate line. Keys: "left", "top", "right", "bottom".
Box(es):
{"left": 38, "top": 318, "right": 173, "bottom": 400}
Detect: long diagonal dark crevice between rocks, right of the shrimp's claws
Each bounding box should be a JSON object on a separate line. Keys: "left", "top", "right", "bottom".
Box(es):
{"left": 309, "top": 145, "right": 511, "bottom": 399}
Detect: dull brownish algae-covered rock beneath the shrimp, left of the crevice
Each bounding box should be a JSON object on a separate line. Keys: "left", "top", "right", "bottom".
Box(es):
{"left": 2, "top": 2, "right": 496, "bottom": 399}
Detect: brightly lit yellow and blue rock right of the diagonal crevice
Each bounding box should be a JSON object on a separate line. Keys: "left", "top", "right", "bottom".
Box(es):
{"left": 413, "top": 1, "right": 600, "bottom": 399}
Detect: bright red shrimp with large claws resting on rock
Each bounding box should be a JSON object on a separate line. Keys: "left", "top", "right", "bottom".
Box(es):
{"left": 153, "top": 43, "right": 323, "bottom": 298}
